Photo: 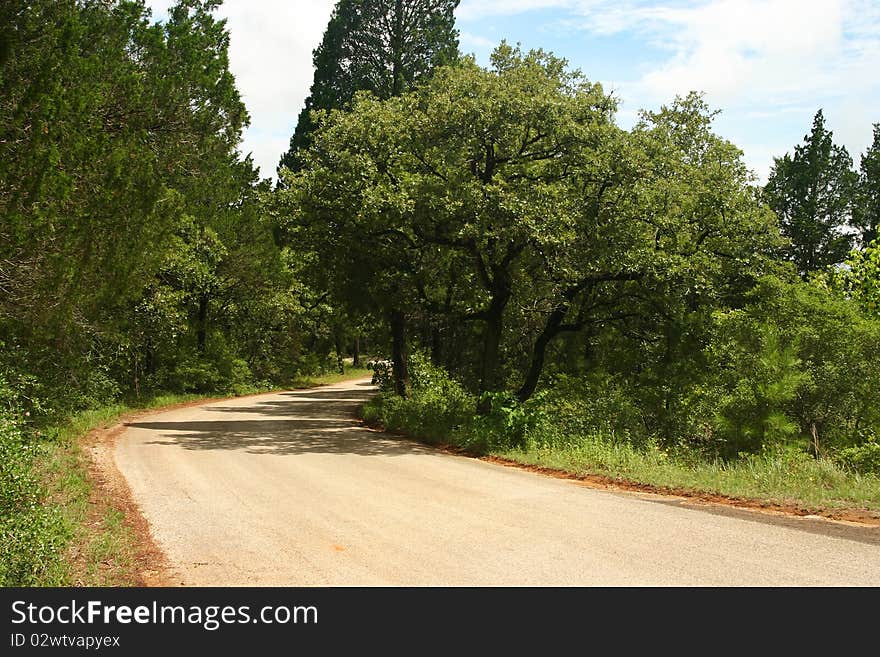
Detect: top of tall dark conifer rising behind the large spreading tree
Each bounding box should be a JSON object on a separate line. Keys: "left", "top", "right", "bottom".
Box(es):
{"left": 279, "top": 0, "right": 459, "bottom": 174}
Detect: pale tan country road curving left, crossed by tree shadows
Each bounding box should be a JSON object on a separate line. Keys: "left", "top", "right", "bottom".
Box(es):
{"left": 114, "top": 381, "right": 880, "bottom": 586}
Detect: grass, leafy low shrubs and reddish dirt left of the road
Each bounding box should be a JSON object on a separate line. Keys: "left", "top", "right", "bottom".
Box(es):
{"left": 0, "top": 366, "right": 371, "bottom": 586}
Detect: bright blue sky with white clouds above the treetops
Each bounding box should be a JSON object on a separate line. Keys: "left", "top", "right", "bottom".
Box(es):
{"left": 146, "top": 0, "right": 880, "bottom": 182}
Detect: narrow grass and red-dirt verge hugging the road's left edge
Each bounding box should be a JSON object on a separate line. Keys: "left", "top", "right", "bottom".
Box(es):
{"left": 28, "top": 368, "right": 372, "bottom": 586}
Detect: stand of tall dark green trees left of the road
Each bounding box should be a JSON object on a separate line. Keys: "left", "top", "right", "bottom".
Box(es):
{"left": 0, "top": 0, "right": 300, "bottom": 405}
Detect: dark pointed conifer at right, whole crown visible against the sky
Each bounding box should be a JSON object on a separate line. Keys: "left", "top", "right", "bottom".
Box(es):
{"left": 764, "top": 109, "right": 856, "bottom": 276}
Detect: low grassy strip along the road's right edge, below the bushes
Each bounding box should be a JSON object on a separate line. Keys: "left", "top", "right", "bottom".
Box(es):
{"left": 364, "top": 388, "right": 880, "bottom": 518}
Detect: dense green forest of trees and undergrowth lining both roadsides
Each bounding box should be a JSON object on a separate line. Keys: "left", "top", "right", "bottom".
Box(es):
{"left": 0, "top": 0, "right": 880, "bottom": 583}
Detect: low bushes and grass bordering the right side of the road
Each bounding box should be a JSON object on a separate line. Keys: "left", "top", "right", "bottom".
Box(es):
{"left": 363, "top": 356, "right": 880, "bottom": 518}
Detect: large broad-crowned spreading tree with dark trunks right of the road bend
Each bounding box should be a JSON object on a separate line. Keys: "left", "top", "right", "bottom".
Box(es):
{"left": 281, "top": 44, "right": 775, "bottom": 411}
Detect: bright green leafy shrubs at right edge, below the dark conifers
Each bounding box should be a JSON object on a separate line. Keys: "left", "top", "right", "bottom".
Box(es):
{"left": 703, "top": 278, "right": 880, "bottom": 462}
